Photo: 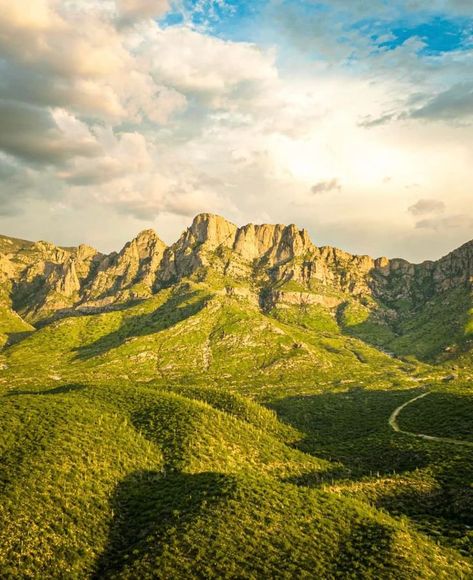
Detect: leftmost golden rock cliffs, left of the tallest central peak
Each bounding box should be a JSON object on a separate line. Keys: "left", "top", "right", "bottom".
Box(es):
{"left": 0, "top": 230, "right": 166, "bottom": 322}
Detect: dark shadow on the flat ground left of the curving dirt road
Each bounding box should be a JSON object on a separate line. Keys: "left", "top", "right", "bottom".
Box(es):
{"left": 269, "top": 388, "right": 431, "bottom": 478}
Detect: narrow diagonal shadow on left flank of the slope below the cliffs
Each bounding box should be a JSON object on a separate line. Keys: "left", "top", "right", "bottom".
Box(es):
{"left": 76, "top": 291, "right": 207, "bottom": 360}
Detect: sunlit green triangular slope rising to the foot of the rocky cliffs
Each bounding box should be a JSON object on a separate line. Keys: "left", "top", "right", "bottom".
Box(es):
{"left": 0, "top": 283, "right": 420, "bottom": 392}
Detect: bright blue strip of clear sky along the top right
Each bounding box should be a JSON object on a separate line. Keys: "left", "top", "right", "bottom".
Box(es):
{"left": 160, "top": 0, "right": 473, "bottom": 55}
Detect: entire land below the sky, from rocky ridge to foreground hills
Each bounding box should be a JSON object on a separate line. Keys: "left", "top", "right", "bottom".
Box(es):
{"left": 0, "top": 214, "right": 473, "bottom": 580}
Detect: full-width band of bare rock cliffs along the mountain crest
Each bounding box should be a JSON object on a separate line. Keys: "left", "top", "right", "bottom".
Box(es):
{"left": 0, "top": 214, "right": 473, "bottom": 322}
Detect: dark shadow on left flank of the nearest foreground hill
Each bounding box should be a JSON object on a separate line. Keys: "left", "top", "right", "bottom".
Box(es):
{"left": 93, "top": 471, "right": 235, "bottom": 580}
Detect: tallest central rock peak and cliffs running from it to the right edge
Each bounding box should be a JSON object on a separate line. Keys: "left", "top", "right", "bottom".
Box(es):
{"left": 157, "top": 214, "right": 473, "bottom": 307}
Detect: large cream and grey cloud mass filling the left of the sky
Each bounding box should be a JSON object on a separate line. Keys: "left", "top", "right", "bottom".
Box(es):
{"left": 0, "top": 0, "right": 277, "bottom": 227}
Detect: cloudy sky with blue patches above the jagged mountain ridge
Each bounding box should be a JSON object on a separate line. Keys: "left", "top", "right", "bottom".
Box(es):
{"left": 0, "top": 0, "right": 473, "bottom": 262}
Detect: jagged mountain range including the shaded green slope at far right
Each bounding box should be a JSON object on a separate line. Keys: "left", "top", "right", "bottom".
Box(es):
{"left": 0, "top": 214, "right": 473, "bottom": 359}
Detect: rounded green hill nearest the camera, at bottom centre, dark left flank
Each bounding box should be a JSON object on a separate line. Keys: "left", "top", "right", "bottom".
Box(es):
{"left": 97, "top": 473, "right": 468, "bottom": 578}
